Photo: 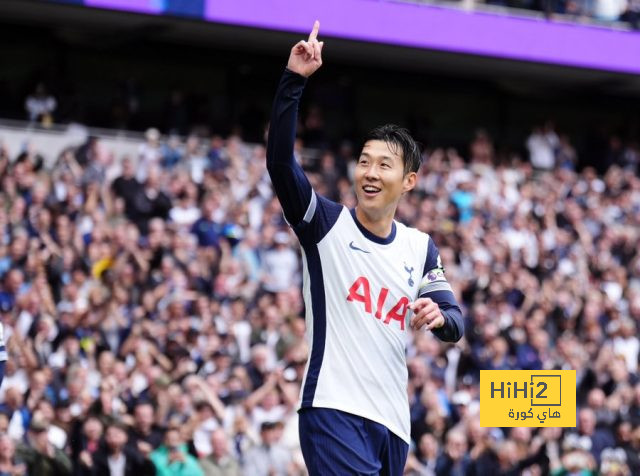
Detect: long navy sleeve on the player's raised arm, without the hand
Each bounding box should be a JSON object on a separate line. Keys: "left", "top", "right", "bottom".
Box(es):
{"left": 267, "top": 70, "right": 315, "bottom": 229}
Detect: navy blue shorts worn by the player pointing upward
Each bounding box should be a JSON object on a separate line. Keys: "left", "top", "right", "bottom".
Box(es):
{"left": 299, "top": 408, "right": 409, "bottom": 476}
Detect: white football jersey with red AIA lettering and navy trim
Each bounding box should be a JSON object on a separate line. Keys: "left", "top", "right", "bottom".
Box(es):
{"left": 293, "top": 192, "right": 451, "bottom": 443}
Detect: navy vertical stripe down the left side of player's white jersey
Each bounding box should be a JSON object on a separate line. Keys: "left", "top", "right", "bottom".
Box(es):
{"left": 300, "top": 243, "right": 327, "bottom": 408}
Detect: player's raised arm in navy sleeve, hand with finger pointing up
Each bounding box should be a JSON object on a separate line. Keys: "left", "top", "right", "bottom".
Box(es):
{"left": 267, "top": 21, "right": 323, "bottom": 226}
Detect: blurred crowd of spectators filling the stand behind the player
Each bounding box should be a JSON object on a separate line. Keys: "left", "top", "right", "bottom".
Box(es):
{"left": 0, "top": 120, "right": 640, "bottom": 476}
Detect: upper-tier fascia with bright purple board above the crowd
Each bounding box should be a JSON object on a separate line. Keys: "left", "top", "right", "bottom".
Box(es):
{"left": 0, "top": 0, "right": 640, "bottom": 94}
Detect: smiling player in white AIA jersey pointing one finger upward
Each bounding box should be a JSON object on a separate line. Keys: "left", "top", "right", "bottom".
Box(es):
{"left": 267, "top": 22, "right": 463, "bottom": 475}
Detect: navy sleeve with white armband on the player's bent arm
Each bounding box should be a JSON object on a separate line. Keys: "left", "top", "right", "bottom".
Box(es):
{"left": 419, "top": 238, "right": 464, "bottom": 342}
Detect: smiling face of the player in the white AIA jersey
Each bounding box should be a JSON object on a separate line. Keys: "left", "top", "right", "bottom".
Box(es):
{"left": 355, "top": 140, "right": 417, "bottom": 219}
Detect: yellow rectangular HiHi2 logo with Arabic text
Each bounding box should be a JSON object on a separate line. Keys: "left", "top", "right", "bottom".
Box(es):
{"left": 480, "top": 370, "right": 576, "bottom": 427}
